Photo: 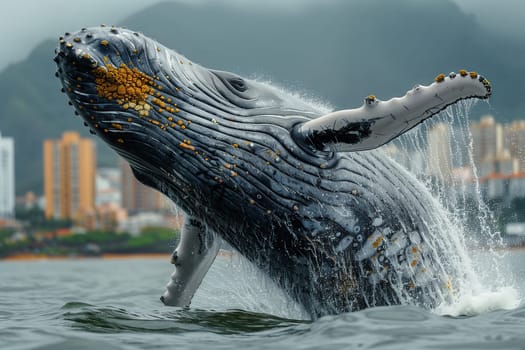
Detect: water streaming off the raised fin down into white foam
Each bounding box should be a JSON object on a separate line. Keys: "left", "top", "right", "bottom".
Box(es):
{"left": 385, "top": 100, "right": 520, "bottom": 316}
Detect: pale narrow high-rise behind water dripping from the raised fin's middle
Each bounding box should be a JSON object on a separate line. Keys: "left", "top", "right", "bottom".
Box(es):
{"left": 427, "top": 123, "right": 452, "bottom": 181}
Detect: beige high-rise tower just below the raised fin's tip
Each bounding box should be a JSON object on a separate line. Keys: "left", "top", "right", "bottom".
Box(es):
{"left": 470, "top": 115, "right": 503, "bottom": 166}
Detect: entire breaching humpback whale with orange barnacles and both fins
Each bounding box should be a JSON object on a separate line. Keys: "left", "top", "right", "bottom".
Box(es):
{"left": 55, "top": 26, "right": 491, "bottom": 318}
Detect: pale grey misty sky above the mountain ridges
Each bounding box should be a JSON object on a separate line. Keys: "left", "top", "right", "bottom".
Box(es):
{"left": 0, "top": 0, "right": 525, "bottom": 70}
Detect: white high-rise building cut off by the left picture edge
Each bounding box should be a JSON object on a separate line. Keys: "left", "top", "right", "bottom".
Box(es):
{"left": 0, "top": 134, "right": 15, "bottom": 219}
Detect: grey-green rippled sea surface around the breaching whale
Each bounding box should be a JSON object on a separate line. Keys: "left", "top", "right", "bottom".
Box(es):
{"left": 0, "top": 251, "right": 525, "bottom": 350}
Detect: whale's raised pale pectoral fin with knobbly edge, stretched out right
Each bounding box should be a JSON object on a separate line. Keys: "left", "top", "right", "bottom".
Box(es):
{"left": 293, "top": 70, "right": 491, "bottom": 152}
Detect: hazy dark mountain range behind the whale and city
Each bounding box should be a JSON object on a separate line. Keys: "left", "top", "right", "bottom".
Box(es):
{"left": 0, "top": 0, "right": 525, "bottom": 194}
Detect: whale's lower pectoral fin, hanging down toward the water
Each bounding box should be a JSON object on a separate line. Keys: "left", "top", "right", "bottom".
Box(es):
{"left": 161, "top": 216, "right": 221, "bottom": 306}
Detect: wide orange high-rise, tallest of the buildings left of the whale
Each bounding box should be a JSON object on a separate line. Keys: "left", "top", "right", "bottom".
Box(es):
{"left": 44, "top": 132, "right": 95, "bottom": 220}
